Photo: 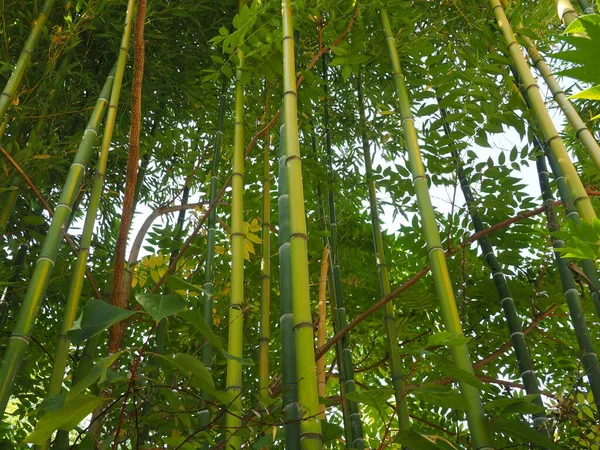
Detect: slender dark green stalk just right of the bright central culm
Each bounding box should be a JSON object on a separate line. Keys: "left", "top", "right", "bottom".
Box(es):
{"left": 323, "top": 55, "right": 365, "bottom": 449}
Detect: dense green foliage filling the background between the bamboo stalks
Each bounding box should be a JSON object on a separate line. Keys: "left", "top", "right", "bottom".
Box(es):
{"left": 0, "top": 0, "right": 600, "bottom": 449}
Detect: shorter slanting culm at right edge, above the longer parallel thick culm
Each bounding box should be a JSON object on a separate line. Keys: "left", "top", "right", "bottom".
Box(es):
{"left": 521, "top": 36, "right": 600, "bottom": 170}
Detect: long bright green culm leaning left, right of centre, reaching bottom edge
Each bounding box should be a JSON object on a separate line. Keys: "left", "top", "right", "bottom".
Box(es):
{"left": 380, "top": 9, "right": 494, "bottom": 450}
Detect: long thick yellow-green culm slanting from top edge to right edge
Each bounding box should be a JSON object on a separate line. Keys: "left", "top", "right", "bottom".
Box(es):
{"left": 490, "top": 0, "right": 596, "bottom": 222}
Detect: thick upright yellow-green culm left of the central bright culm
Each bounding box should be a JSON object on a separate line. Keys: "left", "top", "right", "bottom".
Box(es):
{"left": 226, "top": 0, "right": 244, "bottom": 442}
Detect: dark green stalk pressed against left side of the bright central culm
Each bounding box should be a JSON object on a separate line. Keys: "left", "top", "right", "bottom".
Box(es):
{"left": 277, "top": 119, "right": 300, "bottom": 450}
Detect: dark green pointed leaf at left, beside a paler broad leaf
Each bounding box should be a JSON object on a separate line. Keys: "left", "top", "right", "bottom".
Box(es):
{"left": 67, "top": 298, "right": 135, "bottom": 345}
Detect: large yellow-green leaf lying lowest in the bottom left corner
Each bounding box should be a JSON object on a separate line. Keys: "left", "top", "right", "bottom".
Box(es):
{"left": 24, "top": 394, "right": 108, "bottom": 445}
